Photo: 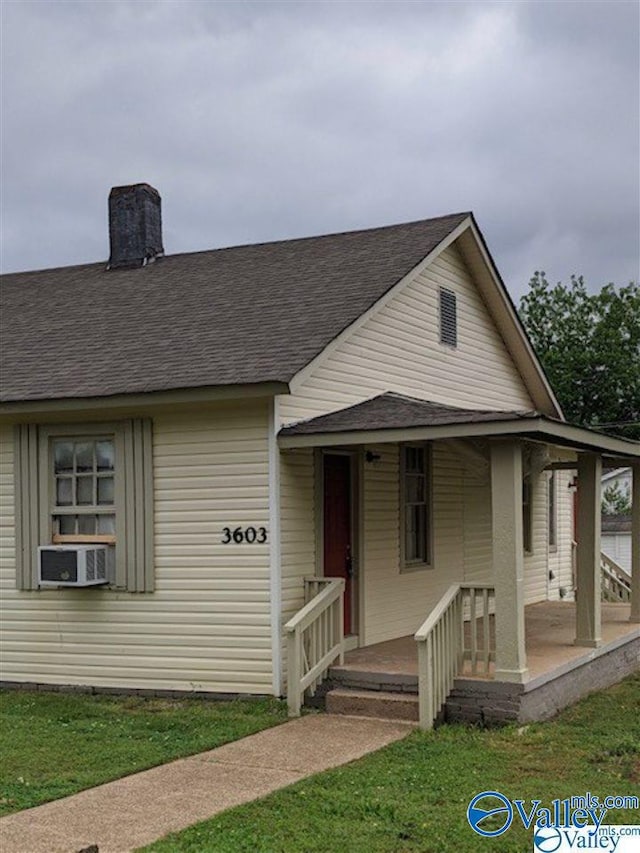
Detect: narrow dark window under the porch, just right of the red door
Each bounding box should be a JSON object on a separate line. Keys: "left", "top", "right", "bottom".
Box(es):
{"left": 400, "top": 445, "right": 431, "bottom": 570}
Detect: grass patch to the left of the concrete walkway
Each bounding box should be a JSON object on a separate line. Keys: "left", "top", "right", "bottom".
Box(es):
{"left": 0, "top": 691, "right": 286, "bottom": 814}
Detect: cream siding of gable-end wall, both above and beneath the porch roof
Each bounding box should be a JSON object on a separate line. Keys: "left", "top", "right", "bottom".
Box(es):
{"left": 279, "top": 240, "right": 547, "bottom": 645}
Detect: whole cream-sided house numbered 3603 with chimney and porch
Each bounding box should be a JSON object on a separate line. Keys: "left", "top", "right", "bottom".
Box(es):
{"left": 0, "top": 184, "right": 640, "bottom": 725}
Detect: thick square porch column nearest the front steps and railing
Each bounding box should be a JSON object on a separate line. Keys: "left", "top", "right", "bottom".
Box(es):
{"left": 491, "top": 441, "right": 527, "bottom": 682}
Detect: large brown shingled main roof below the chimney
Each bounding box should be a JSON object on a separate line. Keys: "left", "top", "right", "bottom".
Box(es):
{"left": 0, "top": 213, "right": 470, "bottom": 402}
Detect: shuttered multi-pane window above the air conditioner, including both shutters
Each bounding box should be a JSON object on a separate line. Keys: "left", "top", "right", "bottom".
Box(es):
{"left": 15, "top": 418, "right": 153, "bottom": 592}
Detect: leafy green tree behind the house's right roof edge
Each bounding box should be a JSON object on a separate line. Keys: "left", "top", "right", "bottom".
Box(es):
{"left": 519, "top": 272, "right": 640, "bottom": 440}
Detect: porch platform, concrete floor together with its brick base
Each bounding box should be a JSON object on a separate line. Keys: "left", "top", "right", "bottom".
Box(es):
{"left": 329, "top": 601, "right": 640, "bottom": 724}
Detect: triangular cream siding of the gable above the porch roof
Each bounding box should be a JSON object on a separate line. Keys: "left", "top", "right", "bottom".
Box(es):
{"left": 280, "top": 244, "right": 533, "bottom": 423}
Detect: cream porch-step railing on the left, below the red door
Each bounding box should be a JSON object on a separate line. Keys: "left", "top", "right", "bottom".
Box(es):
{"left": 284, "top": 578, "right": 345, "bottom": 717}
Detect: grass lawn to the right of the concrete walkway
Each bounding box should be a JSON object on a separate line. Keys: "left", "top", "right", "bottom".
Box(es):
{"left": 144, "top": 674, "right": 640, "bottom": 853}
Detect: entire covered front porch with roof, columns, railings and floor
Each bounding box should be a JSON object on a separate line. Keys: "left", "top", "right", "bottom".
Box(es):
{"left": 279, "top": 394, "right": 640, "bottom": 728}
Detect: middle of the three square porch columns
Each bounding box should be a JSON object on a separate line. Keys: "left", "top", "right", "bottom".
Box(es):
{"left": 575, "top": 453, "right": 602, "bottom": 648}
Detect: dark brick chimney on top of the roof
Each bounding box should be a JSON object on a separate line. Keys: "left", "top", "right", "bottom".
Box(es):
{"left": 107, "top": 184, "right": 164, "bottom": 269}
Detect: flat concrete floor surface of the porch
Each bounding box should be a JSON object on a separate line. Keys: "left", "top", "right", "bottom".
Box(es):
{"left": 332, "top": 601, "right": 640, "bottom": 683}
